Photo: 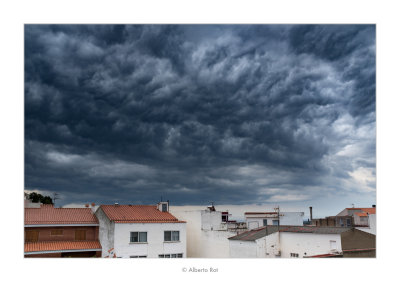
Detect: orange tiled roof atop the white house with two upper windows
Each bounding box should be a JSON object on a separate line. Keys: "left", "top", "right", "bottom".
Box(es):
{"left": 100, "top": 205, "right": 184, "bottom": 223}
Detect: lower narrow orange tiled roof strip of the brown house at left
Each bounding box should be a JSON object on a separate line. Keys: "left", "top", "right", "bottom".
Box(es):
{"left": 24, "top": 241, "right": 101, "bottom": 253}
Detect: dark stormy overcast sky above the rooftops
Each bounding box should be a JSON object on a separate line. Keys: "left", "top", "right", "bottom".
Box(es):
{"left": 25, "top": 25, "right": 376, "bottom": 215}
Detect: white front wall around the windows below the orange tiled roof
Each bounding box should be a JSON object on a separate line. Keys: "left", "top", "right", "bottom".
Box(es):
{"left": 114, "top": 223, "right": 187, "bottom": 258}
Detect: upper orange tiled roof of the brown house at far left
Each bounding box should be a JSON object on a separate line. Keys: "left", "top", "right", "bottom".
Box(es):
{"left": 25, "top": 205, "right": 99, "bottom": 225}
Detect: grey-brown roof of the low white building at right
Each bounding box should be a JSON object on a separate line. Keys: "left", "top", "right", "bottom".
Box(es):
{"left": 228, "top": 225, "right": 351, "bottom": 241}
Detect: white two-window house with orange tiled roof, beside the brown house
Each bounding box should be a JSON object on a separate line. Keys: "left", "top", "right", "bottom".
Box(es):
{"left": 96, "top": 205, "right": 187, "bottom": 258}
